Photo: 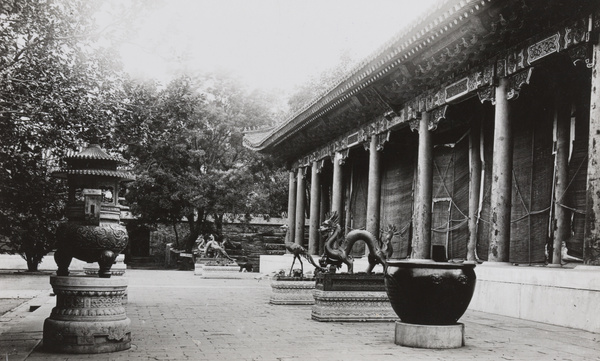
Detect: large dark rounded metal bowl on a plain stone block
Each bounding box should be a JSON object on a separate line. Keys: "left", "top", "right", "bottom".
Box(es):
{"left": 385, "top": 260, "right": 476, "bottom": 325}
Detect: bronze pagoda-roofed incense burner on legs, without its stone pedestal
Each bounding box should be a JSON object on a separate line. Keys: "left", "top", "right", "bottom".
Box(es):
{"left": 53, "top": 144, "right": 133, "bottom": 278}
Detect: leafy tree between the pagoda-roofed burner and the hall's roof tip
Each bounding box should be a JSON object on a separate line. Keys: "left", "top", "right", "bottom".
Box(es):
{"left": 123, "top": 74, "right": 280, "bottom": 251}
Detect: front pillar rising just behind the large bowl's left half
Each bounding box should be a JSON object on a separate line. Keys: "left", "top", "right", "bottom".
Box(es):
{"left": 411, "top": 112, "right": 433, "bottom": 259}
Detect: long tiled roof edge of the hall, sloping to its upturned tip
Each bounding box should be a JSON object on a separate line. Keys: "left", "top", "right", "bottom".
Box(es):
{"left": 244, "top": 0, "right": 488, "bottom": 152}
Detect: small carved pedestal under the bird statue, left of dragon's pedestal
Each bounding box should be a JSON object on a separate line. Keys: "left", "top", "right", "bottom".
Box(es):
{"left": 269, "top": 277, "right": 315, "bottom": 305}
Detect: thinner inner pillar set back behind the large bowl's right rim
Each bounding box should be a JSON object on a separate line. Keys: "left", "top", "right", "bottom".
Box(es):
{"left": 467, "top": 121, "right": 481, "bottom": 261}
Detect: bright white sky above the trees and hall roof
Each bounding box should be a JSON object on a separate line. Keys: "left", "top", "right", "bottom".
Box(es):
{"left": 115, "top": 0, "right": 436, "bottom": 92}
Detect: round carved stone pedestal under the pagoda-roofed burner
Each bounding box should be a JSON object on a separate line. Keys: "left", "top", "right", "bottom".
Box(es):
{"left": 43, "top": 276, "right": 131, "bottom": 354}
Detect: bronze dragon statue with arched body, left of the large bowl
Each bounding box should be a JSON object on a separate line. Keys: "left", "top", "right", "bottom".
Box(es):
{"left": 320, "top": 213, "right": 394, "bottom": 274}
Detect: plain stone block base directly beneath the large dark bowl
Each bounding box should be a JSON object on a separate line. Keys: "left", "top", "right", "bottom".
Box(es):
{"left": 394, "top": 321, "right": 465, "bottom": 349}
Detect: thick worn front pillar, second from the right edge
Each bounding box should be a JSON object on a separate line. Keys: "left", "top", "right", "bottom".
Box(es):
{"left": 488, "top": 78, "right": 513, "bottom": 262}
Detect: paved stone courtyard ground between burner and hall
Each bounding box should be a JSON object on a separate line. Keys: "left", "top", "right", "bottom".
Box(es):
{"left": 0, "top": 270, "right": 600, "bottom": 360}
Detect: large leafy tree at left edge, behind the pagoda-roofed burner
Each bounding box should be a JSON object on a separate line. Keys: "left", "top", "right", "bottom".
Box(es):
{"left": 0, "top": 0, "right": 141, "bottom": 270}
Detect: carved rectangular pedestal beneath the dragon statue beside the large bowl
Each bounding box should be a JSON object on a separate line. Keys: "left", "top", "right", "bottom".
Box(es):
{"left": 311, "top": 273, "right": 398, "bottom": 322}
